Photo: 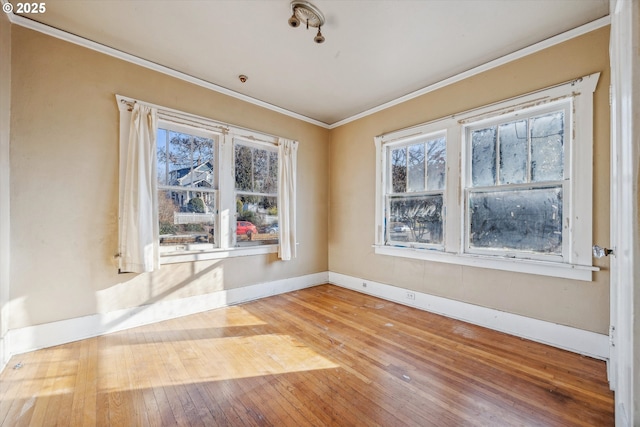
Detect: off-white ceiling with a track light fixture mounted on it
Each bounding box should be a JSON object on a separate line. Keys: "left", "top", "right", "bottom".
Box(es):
{"left": 10, "top": 0, "right": 609, "bottom": 126}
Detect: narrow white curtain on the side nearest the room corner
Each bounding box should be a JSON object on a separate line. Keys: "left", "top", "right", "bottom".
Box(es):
{"left": 278, "top": 138, "right": 298, "bottom": 261}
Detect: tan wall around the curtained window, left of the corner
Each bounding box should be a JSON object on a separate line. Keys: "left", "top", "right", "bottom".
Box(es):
{"left": 8, "top": 26, "right": 329, "bottom": 329}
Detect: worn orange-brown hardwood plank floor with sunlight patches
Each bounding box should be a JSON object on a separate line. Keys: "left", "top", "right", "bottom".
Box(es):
{"left": 0, "top": 285, "right": 614, "bottom": 426}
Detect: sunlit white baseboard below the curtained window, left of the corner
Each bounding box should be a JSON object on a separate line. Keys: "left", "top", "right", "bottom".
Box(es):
{"left": 7, "top": 271, "right": 329, "bottom": 360}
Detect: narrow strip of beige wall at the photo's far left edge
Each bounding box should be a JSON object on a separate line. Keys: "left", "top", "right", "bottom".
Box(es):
{"left": 0, "top": 13, "right": 11, "bottom": 348}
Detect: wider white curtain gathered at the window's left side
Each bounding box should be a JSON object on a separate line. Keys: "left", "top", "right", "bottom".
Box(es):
{"left": 120, "top": 104, "right": 160, "bottom": 273}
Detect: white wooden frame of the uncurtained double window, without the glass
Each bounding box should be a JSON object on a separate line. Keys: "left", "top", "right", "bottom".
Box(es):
{"left": 374, "top": 73, "right": 600, "bottom": 281}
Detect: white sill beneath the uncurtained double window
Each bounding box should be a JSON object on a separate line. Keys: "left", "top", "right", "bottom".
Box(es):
{"left": 373, "top": 245, "right": 600, "bottom": 282}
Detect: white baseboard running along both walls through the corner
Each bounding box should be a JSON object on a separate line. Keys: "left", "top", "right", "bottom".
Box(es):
{"left": 0, "top": 272, "right": 609, "bottom": 372}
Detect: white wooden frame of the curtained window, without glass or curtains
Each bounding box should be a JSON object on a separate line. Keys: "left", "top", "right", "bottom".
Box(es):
{"left": 116, "top": 95, "right": 279, "bottom": 264}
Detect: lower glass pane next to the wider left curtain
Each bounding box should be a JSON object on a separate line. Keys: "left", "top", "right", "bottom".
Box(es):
{"left": 158, "top": 190, "right": 216, "bottom": 245}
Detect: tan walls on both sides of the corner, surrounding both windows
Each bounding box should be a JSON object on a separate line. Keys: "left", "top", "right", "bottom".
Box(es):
{"left": 7, "top": 24, "right": 609, "bottom": 333}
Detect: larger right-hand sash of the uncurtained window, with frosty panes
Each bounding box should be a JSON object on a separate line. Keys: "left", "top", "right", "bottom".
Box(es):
{"left": 465, "top": 105, "right": 571, "bottom": 261}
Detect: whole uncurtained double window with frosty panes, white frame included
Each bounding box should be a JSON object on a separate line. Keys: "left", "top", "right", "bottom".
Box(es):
{"left": 375, "top": 74, "right": 599, "bottom": 280}
